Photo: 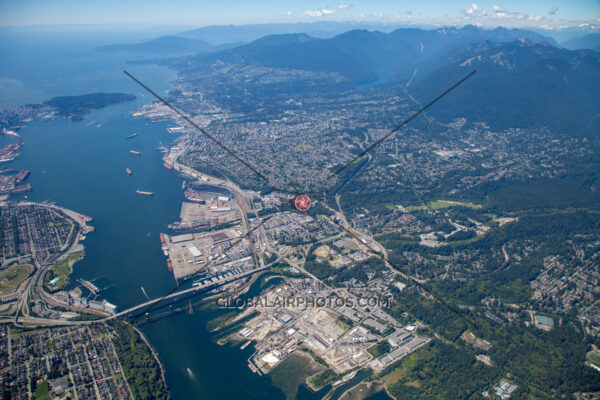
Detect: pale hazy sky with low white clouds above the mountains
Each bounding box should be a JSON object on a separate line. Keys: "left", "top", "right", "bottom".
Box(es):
{"left": 0, "top": 0, "right": 600, "bottom": 31}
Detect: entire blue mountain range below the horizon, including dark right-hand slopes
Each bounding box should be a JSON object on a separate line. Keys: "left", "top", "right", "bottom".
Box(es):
{"left": 149, "top": 25, "right": 600, "bottom": 133}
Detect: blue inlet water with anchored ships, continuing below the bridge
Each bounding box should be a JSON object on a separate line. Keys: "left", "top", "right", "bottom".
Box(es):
{"left": 0, "top": 32, "right": 283, "bottom": 399}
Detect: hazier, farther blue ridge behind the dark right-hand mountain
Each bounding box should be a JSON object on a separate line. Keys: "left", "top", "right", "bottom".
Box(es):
{"left": 165, "top": 25, "right": 555, "bottom": 82}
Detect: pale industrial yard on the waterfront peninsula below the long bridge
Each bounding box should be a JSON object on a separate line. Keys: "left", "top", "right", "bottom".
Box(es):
{"left": 227, "top": 278, "right": 429, "bottom": 374}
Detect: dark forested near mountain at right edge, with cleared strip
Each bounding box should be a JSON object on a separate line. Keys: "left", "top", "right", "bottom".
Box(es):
{"left": 412, "top": 40, "right": 600, "bottom": 135}
